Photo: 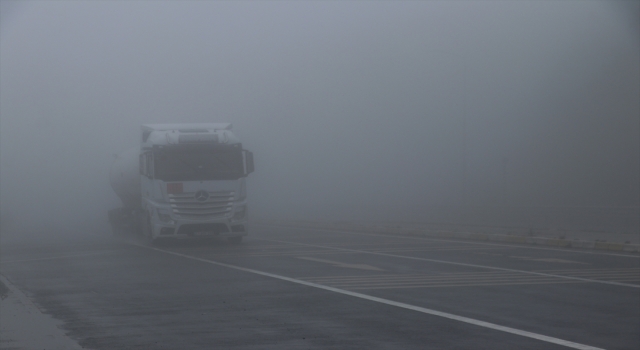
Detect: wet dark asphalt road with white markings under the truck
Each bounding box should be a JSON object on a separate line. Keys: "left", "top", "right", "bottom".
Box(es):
{"left": 0, "top": 226, "right": 640, "bottom": 350}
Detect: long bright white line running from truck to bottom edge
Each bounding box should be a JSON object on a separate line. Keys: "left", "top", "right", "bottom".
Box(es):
{"left": 136, "top": 244, "right": 604, "bottom": 350}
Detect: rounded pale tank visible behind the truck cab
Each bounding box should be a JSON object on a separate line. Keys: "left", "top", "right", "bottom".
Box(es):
{"left": 109, "top": 146, "right": 140, "bottom": 208}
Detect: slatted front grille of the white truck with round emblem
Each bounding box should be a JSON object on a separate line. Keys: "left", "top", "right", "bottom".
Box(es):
{"left": 169, "top": 191, "right": 235, "bottom": 219}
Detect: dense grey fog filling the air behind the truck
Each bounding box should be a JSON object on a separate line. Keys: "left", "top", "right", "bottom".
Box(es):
{"left": 0, "top": 1, "right": 640, "bottom": 234}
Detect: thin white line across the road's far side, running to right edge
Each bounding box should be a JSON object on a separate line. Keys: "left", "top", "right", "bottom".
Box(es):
{"left": 254, "top": 238, "right": 640, "bottom": 288}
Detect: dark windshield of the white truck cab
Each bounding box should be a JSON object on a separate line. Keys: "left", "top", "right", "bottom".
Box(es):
{"left": 155, "top": 147, "right": 244, "bottom": 181}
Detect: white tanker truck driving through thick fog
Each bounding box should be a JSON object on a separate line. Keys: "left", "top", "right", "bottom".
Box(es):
{"left": 109, "top": 123, "right": 253, "bottom": 243}
